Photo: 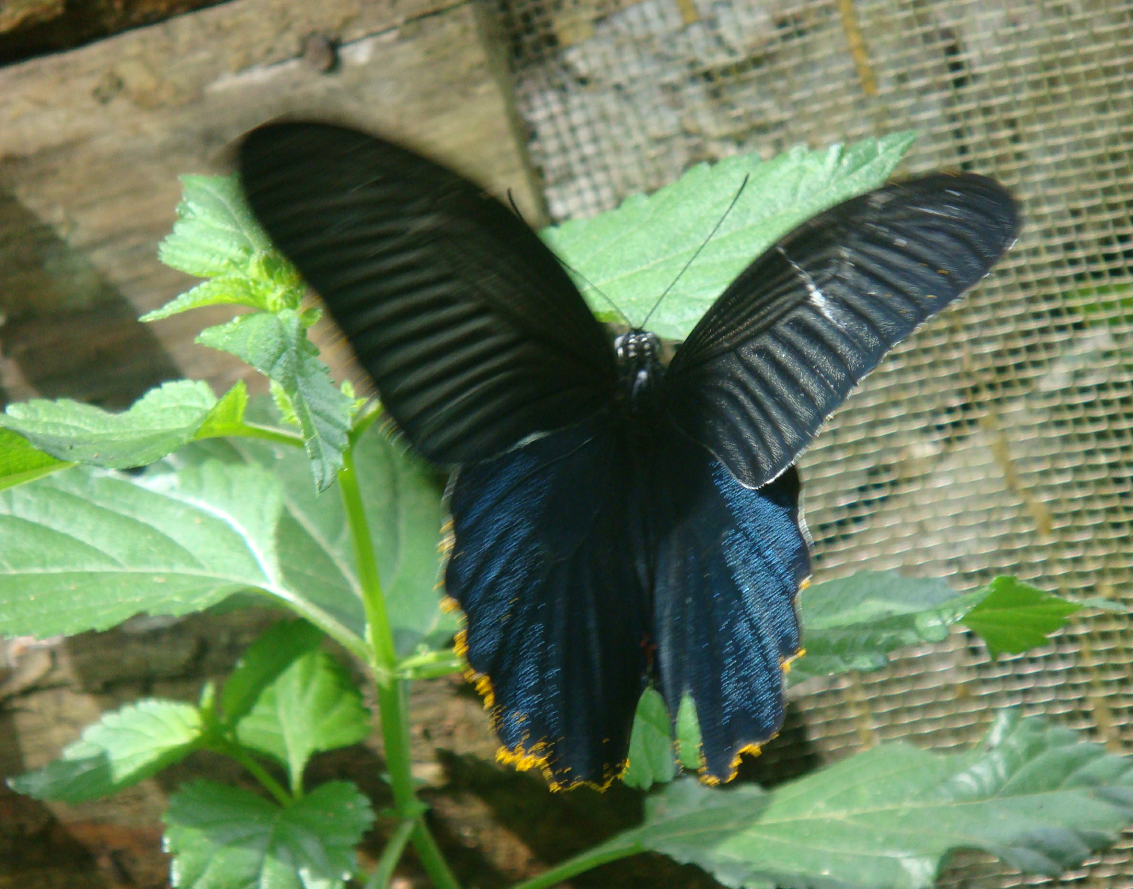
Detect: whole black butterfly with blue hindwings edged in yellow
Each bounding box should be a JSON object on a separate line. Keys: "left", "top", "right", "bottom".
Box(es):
{"left": 239, "top": 123, "right": 1016, "bottom": 786}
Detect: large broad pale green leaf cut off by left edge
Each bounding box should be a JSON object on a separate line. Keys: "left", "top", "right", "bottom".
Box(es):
{"left": 0, "top": 461, "right": 295, "bottom": 636}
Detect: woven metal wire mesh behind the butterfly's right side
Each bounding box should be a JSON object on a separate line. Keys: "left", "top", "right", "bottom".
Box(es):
{"left": 501, "top": 0, "right": 1133, "bottom": 889}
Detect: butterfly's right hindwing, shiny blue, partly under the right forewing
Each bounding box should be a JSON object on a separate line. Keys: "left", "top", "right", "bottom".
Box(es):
{"left": 651, "top": 430, "right": 810, "bottom": 783}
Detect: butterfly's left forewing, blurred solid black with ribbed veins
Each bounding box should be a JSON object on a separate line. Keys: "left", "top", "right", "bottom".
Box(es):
{"left": 238, "top": 122, "right": 615, "bottom": 463}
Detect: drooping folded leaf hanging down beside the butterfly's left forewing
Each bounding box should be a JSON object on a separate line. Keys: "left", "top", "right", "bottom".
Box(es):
{"left": 197, "top": 309, "right": 351, "bottom": 490}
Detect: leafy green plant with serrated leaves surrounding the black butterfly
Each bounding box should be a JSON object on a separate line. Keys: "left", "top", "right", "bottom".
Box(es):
{"left": 0, "top": 134, "right": 1133, "bottom": 889}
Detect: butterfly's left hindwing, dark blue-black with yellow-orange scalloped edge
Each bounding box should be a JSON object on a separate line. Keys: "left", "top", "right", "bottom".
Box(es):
{"left": 445, "top": 417, "right": 649, "bottom": 788}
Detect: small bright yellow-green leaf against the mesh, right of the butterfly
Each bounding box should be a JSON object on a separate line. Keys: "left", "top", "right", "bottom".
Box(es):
{"left": 963, "top": 576, "right": 1082, "bottom": 658}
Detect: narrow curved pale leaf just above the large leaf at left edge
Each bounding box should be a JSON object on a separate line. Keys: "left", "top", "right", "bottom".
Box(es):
{"left": 0, "top": 379, "right": 232, "bottom": 469}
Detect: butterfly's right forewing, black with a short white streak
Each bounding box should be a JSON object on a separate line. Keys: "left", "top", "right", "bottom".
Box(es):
{"left": 663, "top": 173, "right": 1017, "bottom": 488}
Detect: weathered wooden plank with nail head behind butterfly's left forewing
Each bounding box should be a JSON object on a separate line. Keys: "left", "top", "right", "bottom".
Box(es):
{"left": 0, "top": 0, "right": 539, "bottom": 405}
